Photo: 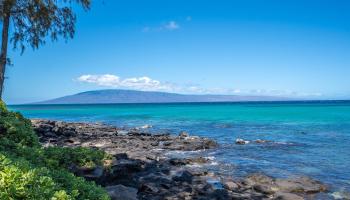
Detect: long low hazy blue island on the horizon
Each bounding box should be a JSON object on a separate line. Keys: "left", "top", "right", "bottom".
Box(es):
{"left": 35, "top": 89, "right": 292, "bottom": 104}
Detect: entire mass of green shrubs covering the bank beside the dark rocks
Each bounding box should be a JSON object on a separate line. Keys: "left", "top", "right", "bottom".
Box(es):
{"left": 0, "top": 103, "right": 109, "bottom": 200}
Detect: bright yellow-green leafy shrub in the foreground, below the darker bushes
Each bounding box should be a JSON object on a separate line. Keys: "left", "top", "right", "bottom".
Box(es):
{"left": 0, "top": 153, "right": 109, "bottom": 200}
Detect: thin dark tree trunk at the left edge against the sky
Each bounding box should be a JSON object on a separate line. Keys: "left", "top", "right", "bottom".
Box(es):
{"left": 0, "top": 9, "right": 10, "bottom": 100}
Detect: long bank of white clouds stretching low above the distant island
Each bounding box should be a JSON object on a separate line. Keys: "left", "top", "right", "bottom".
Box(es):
{"left": 76, "top": 74, "right": 323, "bottom": 98}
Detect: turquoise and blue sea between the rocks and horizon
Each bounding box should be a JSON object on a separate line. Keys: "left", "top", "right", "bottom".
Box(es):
{"left": 10, "top": 101, "right": 350, "bottom": 194}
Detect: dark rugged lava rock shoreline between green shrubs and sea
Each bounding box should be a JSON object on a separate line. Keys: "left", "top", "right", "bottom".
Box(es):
{"left": 32, "top": 120, "right": 327, "bottom": 200}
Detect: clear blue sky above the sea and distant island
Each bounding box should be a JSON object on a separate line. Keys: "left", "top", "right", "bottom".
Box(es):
{"left": 4, "top": 0, "right": 350, "bottom": 104}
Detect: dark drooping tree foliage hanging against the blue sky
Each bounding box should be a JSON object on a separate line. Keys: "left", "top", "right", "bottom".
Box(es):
{"left": 0, "top": 0, "right": 91, "bottom": 53}
